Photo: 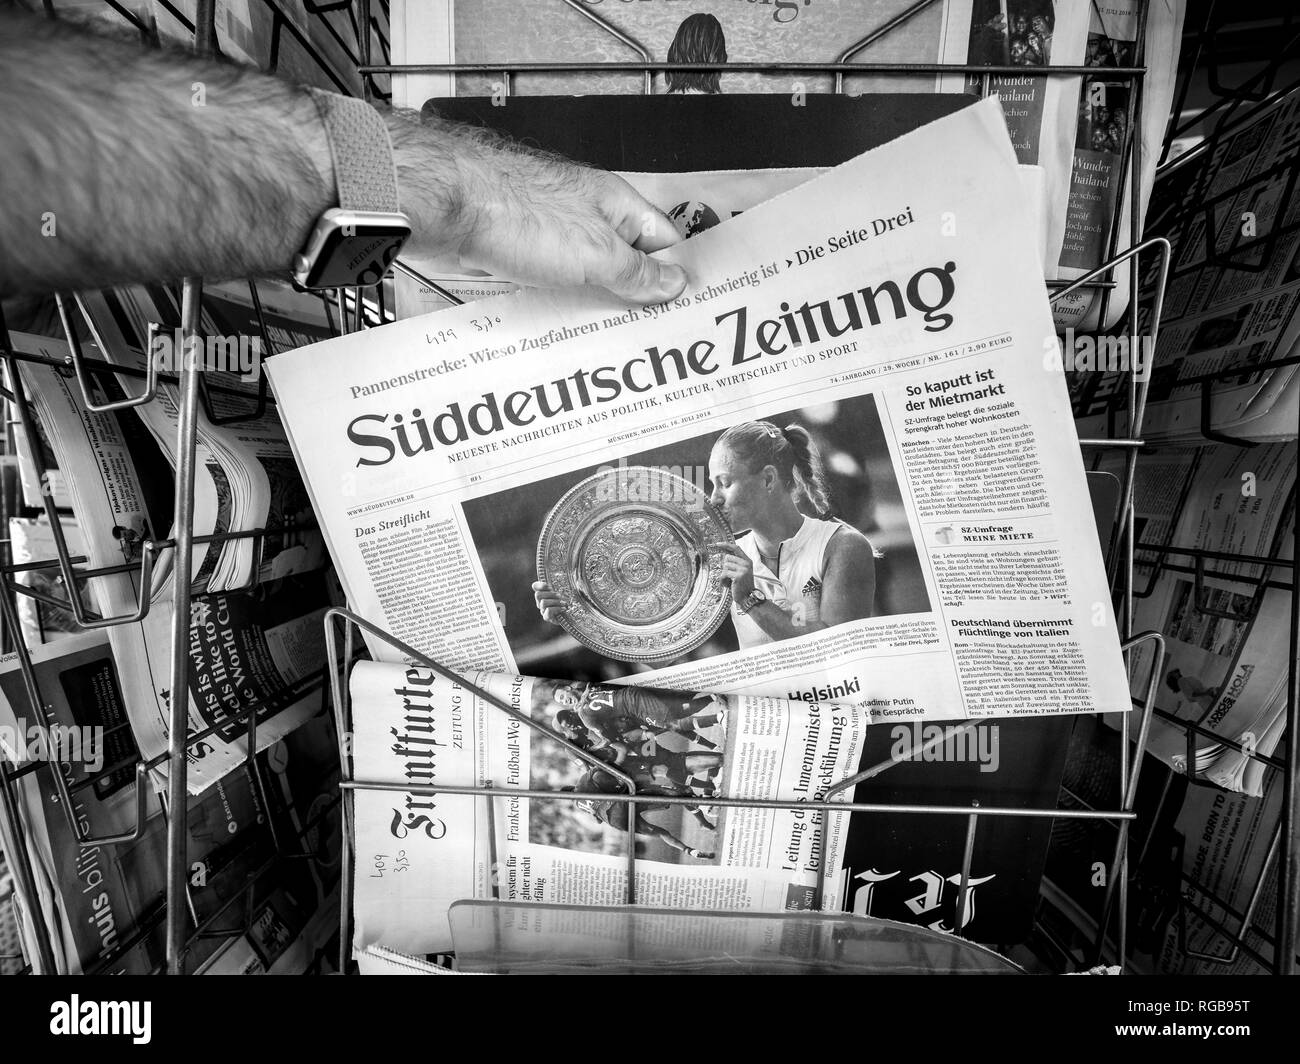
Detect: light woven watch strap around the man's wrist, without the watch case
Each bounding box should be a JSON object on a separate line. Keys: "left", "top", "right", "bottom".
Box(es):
{"left": 308, "top": 88, "right": 400, "bottom": 213}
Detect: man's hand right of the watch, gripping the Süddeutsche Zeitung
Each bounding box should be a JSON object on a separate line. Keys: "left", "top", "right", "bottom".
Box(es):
{"left": 390, "top": 116, "right": 686, "bottom": 303}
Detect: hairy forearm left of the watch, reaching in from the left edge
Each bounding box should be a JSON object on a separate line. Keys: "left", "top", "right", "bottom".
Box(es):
{"left": 0, "top": 12, "right": 335, "bottom": 294}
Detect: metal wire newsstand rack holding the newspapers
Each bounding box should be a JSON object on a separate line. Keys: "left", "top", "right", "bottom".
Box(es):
{"left": 0, "top": 0, "right": 1300, "bottom": 974}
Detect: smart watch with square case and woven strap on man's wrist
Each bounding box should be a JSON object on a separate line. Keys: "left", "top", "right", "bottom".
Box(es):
{"left": 294, "top": 88, "right": 411, "bottom": 289}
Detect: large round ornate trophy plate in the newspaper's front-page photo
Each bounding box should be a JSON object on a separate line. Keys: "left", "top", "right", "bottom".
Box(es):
{"left": 537, "top": 466, "right": 735, "bottom": 662}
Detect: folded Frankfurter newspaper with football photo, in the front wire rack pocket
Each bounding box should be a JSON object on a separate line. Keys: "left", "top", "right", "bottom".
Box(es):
{"left": 351, "top": 662, "right": 870, "bottom": 955}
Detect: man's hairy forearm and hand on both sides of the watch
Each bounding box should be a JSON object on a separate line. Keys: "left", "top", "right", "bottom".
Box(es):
{"left": 0, "top": 8, "right": 686, "bottom": 303}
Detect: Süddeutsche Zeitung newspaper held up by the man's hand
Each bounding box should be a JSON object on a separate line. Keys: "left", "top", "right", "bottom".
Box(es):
{"left": 268, "top": 100, "right": 1128, "bottom": 719}
